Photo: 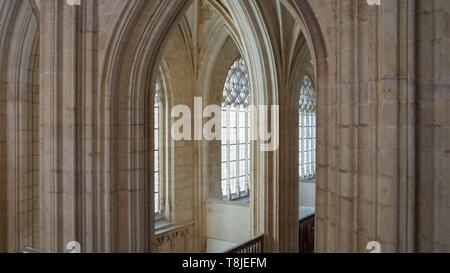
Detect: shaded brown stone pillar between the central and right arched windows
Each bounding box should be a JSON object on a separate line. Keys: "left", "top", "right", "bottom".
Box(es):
{"left": 278, "top": 39, "right": 314, "bottom": 253}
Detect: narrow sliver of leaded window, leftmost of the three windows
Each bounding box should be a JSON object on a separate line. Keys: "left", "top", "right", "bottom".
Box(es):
{"left": 153, "top": 80, "right": 162, "bottom": 215}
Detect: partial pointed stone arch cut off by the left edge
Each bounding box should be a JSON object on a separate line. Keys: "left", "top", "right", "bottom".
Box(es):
{"left": 0, "top": 1, "right": 39, "bottom": 252}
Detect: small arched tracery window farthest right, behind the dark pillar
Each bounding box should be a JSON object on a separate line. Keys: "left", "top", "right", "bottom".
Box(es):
{"left": 299, "top": 76, "right": 316, "bottom": 181}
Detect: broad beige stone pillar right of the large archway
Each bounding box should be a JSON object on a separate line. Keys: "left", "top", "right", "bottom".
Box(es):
{"left": 317, "top": 0, "right": 415, "bottom": 252}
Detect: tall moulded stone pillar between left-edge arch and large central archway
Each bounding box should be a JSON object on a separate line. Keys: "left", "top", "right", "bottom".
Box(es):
{"left": 40, "top": 0, "right": 102, "bottom": 252}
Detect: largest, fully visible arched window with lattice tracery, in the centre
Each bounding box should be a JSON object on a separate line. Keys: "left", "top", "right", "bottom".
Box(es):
{"left": 222, "top": 59, "right": 250, "bottom": 200}
